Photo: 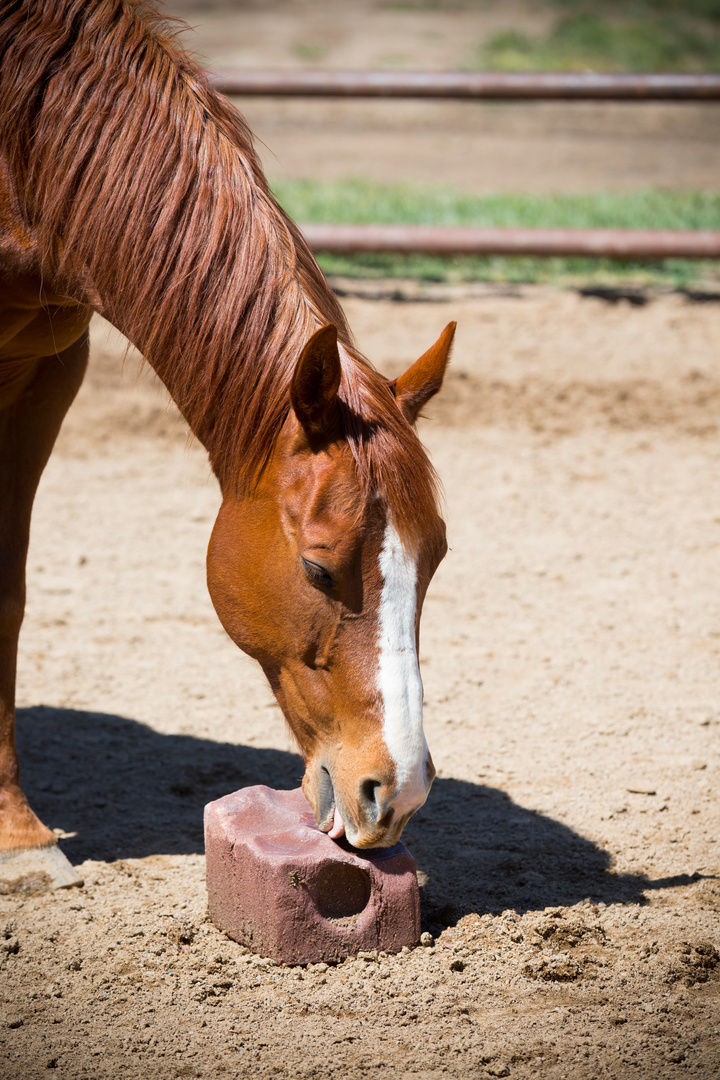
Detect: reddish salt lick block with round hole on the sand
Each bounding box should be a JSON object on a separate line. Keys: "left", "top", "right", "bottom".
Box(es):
{"left": 205, "top": 784, "right": 420, "bottom": 963}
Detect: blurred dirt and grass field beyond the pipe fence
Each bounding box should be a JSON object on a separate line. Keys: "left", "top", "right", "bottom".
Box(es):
{"left": 162, "top": 0, "right": 720, "bottom": 289}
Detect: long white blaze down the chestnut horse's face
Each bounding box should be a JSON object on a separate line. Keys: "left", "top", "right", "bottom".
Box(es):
{"left": 378, "top": 521, "right": 427, "bottom": 818}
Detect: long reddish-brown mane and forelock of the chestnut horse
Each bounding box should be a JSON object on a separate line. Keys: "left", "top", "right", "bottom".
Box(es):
{"left": 0, "top": 0, "right": 437, "bottom": 539}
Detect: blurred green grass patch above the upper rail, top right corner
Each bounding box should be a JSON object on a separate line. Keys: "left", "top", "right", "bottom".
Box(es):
{"left": 476, "top": 0, "right": 720, "bottom": 71}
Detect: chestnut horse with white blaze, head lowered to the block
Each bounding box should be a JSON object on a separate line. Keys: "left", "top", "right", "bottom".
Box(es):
{"left": 0, "top": 0, "right": 454, "bottom": 876}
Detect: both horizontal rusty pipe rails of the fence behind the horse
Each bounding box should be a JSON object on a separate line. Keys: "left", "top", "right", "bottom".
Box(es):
{"left": 208, "top": 69, "right": 720, "bottom": 259}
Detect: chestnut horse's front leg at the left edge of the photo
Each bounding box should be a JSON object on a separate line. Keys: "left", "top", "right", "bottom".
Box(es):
{"left": 0, "top": 333, "right": 87, "bottom": 883}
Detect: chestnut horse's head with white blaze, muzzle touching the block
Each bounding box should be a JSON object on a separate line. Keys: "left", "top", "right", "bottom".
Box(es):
{"left": 207, "top": 323, "right": 454, "bottom": 848}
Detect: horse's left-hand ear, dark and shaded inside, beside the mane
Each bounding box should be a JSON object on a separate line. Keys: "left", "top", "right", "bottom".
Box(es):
{"left": 290, "top": 323, "right": 342, "bottom": 440}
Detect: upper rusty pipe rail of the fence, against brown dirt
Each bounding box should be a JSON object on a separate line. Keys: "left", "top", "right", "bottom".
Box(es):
{"left": 208, "top": 68, "right": 720, "bottom": 102}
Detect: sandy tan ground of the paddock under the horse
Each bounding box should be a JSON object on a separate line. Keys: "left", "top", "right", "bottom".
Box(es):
{"left": 0, "top": 289, "right": 720, "bottom": 1080}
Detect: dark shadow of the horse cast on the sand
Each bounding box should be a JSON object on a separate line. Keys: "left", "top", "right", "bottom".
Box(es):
{"left": 17, "top": 705, "right": 697, "bottom": 932}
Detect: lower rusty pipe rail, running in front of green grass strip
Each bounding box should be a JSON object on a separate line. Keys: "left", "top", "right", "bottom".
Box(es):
{"left": 300, "top": 225, "right": 720, "bottom": 259}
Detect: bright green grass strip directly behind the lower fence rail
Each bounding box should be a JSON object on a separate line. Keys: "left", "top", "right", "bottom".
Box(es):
{"left": 275, "top": 180, "right": 720, "bottom": 288}
